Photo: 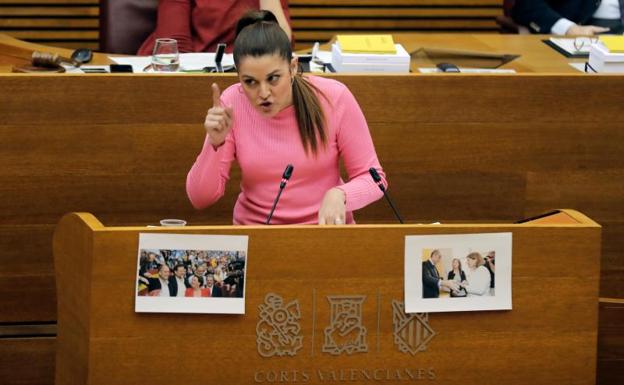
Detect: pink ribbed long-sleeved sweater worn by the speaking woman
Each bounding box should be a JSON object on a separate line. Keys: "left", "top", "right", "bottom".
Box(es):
{"left": 186, "top": 76, "right": 386, "bottom": 224}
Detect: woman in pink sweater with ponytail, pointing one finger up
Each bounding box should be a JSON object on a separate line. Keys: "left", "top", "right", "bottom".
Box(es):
{"left": 186, "top": 11, "right": 386, "bottom": 224}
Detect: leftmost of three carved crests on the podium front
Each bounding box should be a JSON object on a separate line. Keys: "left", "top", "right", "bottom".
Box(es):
{"left": 256, "top": 293, "right": 303, "bottom": 357}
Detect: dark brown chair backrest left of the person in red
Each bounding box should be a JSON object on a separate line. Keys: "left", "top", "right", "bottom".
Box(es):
{"left": 100, "top": 0, "right": 158, "bottom": 55}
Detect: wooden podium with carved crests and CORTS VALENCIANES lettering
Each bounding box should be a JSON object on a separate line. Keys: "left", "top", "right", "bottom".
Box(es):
{"left": 54, "top": 210, "right": 601, "bottom": 385}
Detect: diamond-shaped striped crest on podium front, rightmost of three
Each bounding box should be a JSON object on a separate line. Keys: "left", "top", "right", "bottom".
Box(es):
{"left": 392, "top": 301, "right": 436, "bottom": 355}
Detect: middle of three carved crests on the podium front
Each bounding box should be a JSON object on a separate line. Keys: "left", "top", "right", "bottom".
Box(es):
{"left": 323, "top": 296, "right": 368, "bottom": 355}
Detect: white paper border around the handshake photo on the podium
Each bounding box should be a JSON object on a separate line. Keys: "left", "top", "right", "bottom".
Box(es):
{"left": 404, "top": 233, "right": 512, "bottom": 313}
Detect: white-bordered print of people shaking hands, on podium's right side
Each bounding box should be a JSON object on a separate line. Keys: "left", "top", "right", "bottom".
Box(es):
{"left": 405, "top": 233, "right": 512, "bottom": 313}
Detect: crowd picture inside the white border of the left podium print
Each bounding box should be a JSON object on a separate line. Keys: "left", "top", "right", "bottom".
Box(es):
{"left": 137, "top": 249, "right": 246, "bottom": 298}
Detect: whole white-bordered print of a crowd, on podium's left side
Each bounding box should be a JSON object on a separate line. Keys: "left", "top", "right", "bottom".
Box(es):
{"left": 135, "top": 233, "right": 248, "bottom": 314}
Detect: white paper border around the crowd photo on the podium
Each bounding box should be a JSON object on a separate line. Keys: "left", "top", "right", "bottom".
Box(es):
{"left": 134, "top": 233, "right": 249, "bottom": 314}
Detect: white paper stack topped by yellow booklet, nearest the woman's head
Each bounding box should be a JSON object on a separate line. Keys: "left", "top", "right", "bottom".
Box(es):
{"left": 332, "top": 35, "right": 410, "bottom": 73}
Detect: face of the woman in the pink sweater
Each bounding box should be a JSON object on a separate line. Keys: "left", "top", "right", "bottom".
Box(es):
{"left": 238, "top": 54, "right": 297, "bottom": 118}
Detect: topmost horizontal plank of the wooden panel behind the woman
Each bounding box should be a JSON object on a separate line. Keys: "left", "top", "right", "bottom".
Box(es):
{"left": 0, "top": 74, "right": 620, "bottom": 124}
